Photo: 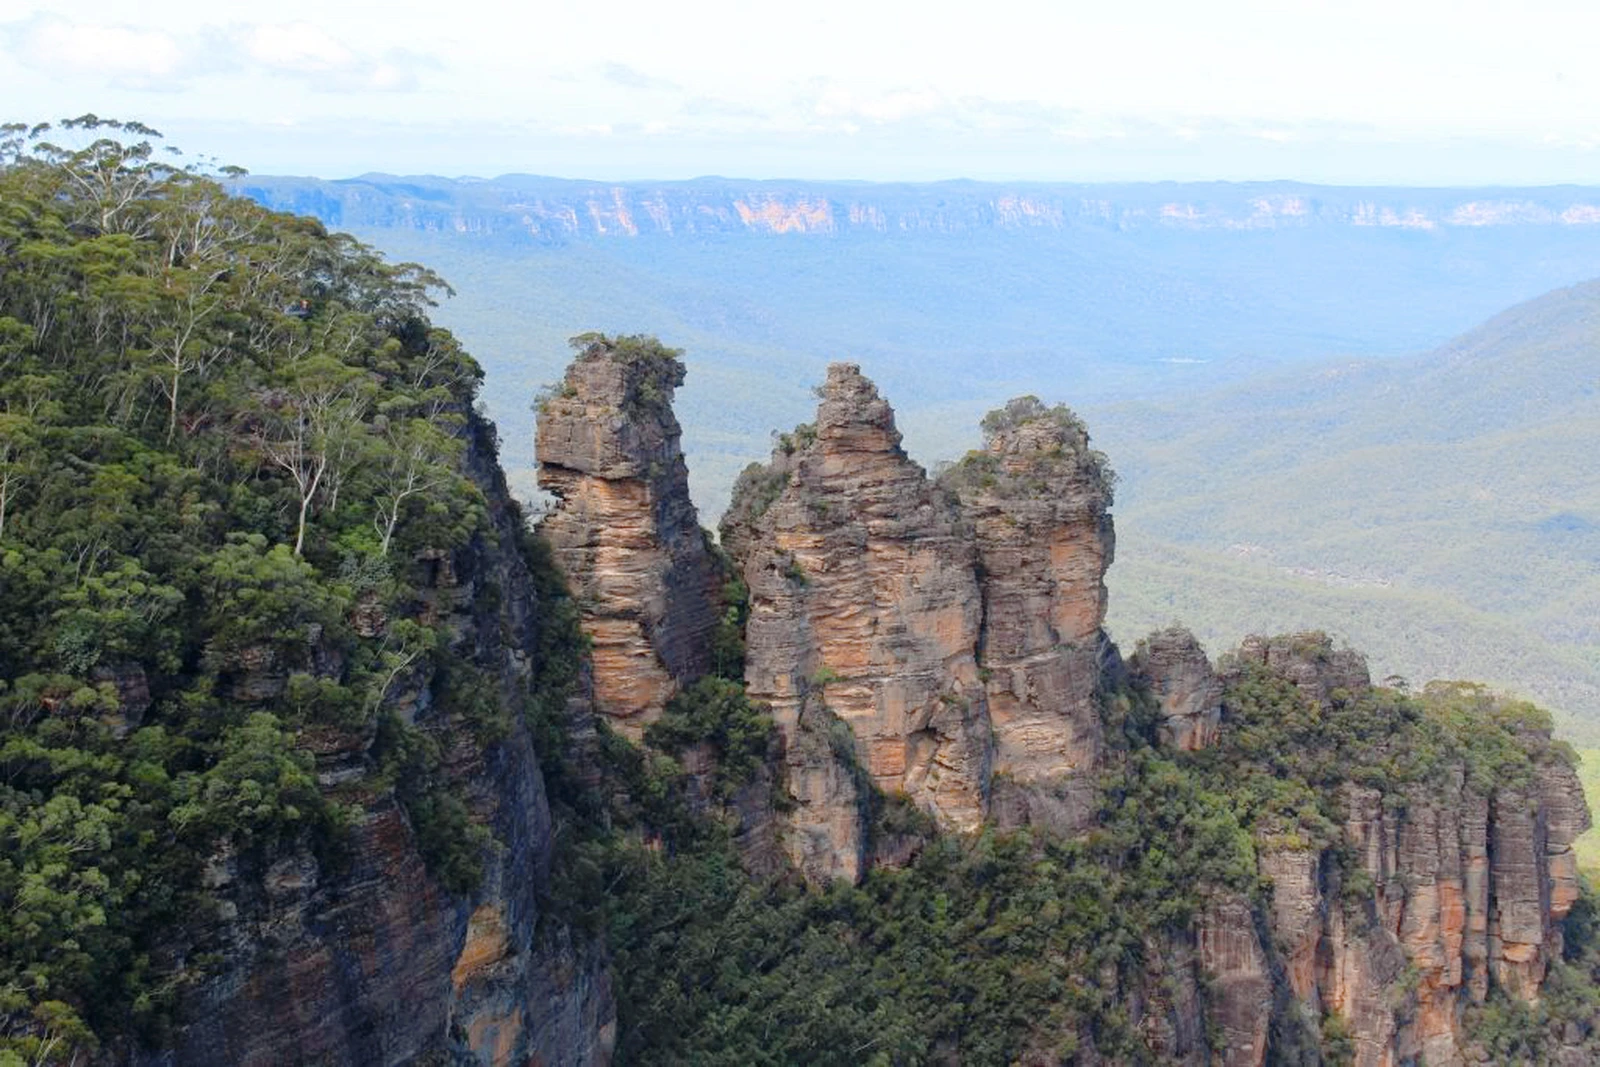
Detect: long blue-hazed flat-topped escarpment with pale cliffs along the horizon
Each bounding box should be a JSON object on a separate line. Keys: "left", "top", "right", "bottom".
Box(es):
{"left": 238, "top": 174, "right": 1600, "bottom": 242}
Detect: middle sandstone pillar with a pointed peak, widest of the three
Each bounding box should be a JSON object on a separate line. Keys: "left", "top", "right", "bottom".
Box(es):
{"left": 725, "top": 363, "right": 990, "bottom": 857}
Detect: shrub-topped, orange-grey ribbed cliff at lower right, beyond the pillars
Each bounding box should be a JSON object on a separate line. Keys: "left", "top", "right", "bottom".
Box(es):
{"left": 1219, "top": 633, "right": 1589, "bottom": 1067}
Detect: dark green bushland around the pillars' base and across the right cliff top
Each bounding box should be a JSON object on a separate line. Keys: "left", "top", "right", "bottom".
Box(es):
{"left": 528, "top": 620, "right": 1594, "bottom": 1064}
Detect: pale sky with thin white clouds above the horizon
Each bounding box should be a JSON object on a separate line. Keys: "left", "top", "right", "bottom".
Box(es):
{"left": 9, "top": 0, "right": 1600, "bottom": 186}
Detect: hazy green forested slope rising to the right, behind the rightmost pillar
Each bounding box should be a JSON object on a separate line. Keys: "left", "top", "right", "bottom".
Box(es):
{"left": 1096, "top": 283, "right": 1600, "bottom": 742}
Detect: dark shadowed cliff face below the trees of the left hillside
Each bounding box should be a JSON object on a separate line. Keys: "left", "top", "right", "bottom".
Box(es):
{"left": 150, "top": 424, "right": 616, "bottom": 1067}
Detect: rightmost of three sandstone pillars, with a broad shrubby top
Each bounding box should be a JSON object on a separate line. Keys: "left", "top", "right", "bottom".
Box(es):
{"left": 941, "top": 397, "right": 1115, "bottom": 829}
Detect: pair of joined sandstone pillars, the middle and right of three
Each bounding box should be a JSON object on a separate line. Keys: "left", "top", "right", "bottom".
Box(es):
{"left": 723, "top": 363, "right": 1115, "bottom": 877}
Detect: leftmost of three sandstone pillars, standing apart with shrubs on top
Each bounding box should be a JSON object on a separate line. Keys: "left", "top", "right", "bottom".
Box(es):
{"left": 538, "top": 334, "right": 718, "bottom": 741}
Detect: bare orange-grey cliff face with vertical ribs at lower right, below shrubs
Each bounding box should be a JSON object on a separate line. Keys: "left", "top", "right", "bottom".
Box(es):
{"left": 1203, "top": 633, "right": 1589, "bottom": 1067}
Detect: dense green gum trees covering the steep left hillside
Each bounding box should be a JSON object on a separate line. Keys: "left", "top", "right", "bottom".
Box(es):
{"left": 0, "top": 115, "right": 505, "bottom": 1064}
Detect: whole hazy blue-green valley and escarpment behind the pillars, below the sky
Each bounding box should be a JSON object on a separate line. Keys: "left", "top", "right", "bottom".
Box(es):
{"left": 238, "top": 176, "right": 1600, "bottom": 739}
